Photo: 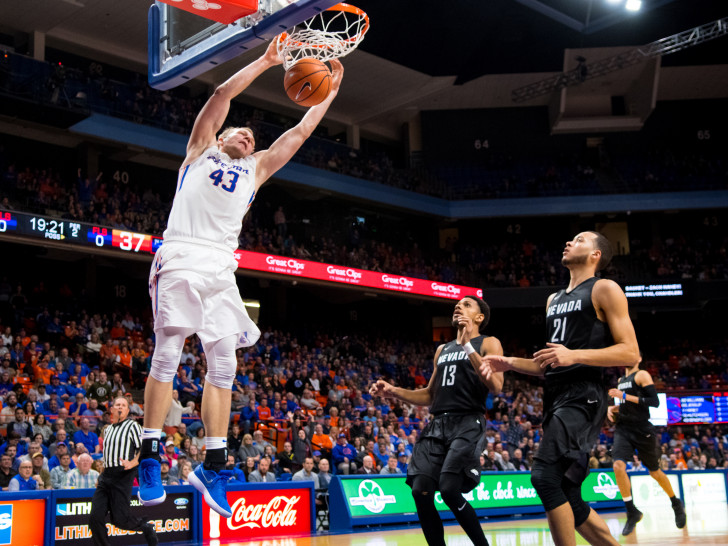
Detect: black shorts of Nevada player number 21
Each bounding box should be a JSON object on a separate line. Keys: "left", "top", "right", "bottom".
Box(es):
{"left": 534, "top": 381, "right": 608, "bottom": 465}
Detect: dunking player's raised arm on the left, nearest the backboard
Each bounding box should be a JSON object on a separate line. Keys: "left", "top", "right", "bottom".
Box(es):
{"left": 182, "top": 39, "right": 282, "bottom": 167}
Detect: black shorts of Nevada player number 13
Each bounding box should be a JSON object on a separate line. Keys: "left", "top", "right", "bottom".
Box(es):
{"left": 407, "top": 413, "right": 485, "bottom": 493}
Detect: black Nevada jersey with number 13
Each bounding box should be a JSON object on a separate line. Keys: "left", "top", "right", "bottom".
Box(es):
{"left": 430, "top": 336, "right": 488, "bottom": 415}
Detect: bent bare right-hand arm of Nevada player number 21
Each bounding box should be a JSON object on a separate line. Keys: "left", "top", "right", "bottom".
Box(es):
{"left": 533, "top": 279, "right": 640, "bottom": 368}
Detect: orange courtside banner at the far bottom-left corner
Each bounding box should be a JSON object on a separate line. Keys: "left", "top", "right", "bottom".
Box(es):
{"left": 0, "top": 499, "right": 47, "bottom": 546}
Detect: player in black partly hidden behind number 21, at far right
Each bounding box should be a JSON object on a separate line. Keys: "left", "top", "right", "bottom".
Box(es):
{"left": 607, "top": 356, "right": 686, "bottom": 535}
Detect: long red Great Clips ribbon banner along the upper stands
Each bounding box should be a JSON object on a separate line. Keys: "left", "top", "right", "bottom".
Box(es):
{"left": 235, "top": 250, "right": 483, "bottom": 300}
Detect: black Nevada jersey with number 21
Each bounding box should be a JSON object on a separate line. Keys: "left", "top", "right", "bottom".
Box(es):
{"left": 544, "top": 277, "right": 614, "bottom": 386}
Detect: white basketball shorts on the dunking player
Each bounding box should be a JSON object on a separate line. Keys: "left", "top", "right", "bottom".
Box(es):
{"left": 149, "top": 241, "right": 260, "bottom": 347}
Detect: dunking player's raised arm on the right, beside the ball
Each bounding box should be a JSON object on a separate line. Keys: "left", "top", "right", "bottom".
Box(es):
{"left": 254, "top": 59, "right": 344, "bottom": 190}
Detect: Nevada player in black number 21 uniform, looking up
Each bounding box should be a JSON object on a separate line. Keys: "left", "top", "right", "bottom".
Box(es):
{"left": 481, "top": 231, "right": 639, "bottom": 546}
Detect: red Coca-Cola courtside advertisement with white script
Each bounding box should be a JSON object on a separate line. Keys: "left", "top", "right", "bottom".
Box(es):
{"left": 202, "top": 482, "right": 315, "bottom": 544}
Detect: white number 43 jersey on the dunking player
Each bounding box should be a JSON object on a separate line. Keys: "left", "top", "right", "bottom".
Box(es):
{"left": 164, "top": 146, "right": 256, "bottom": 251}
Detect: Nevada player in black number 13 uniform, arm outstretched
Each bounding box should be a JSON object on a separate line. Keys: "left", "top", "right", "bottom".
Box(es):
{"left": 369, "top": 296, "right": 503, "bottom": 546}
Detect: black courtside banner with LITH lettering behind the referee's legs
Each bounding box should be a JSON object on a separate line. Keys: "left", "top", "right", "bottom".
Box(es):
{"left": 53, "top": 489, "right": 195, "bottom": 546}
